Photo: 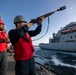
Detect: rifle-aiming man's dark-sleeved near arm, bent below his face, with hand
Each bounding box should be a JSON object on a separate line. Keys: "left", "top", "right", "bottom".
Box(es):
{"left": 9, "top": 23, "right": 33, "bottom": 43}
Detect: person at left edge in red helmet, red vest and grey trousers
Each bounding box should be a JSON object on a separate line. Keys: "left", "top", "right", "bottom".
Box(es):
{"left": 0, "top": 19, "right": 9, "bottom": 75}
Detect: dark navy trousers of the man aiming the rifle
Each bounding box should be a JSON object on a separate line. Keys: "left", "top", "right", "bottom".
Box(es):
{"left": 15, "top": 58, "right": 36, "bottom": 75}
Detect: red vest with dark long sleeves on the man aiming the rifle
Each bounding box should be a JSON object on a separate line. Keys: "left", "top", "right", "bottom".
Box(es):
{"left": 9, "top": 25, "right": 42, "bottom": 60}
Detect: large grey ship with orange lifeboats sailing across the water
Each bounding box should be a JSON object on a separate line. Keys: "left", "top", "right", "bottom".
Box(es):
{"left": 39, "top": 22, "right": 76, "bottom": 51}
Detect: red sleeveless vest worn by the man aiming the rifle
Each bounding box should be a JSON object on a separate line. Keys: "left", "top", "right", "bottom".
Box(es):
{"left": 13, "top": 34, "right": 34, "bottom": 60}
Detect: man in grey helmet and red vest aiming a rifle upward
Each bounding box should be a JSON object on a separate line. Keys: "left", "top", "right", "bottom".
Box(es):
{"left": 9, "top": 15, "right": 44, "bottom": 75}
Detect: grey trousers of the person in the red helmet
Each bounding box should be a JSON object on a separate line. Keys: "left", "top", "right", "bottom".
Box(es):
{"left": 0, "top": 52, "right": 7, "bottom": 75}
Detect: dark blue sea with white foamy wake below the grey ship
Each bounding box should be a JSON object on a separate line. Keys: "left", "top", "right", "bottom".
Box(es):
{"left": 35, "top": 47, "right": 76, "bottom": 75}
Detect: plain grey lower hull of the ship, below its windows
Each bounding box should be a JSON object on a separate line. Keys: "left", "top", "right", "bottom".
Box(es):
{"left": 39, "top": 43, "right": 76, "bottom": 51}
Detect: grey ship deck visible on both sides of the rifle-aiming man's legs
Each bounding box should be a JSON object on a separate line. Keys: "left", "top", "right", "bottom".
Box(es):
{"left": 7, "top": 56, "right": 56, "bottom": 75}
